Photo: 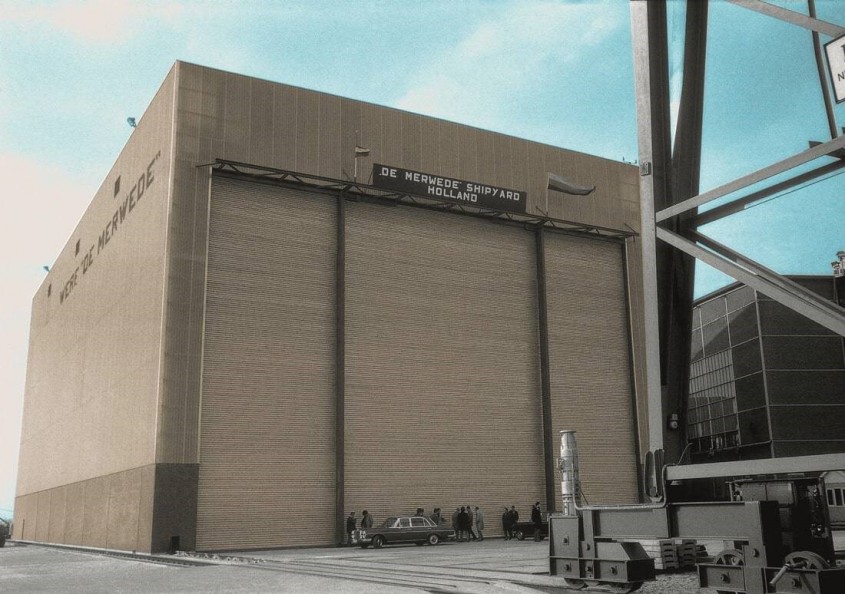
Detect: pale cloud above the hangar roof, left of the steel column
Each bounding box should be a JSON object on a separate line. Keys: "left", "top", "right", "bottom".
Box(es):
{"left": 394, "top": 2, "right": 623, "bottom": 129}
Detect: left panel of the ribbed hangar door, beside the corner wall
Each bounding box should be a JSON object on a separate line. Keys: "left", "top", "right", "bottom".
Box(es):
{"left": 196, "top": 178, "right": 336, "bottom": 550}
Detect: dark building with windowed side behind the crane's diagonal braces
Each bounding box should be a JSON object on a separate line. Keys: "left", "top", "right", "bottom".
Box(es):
{"left": 687, "top": 276, "right": 845, "bottom": 462}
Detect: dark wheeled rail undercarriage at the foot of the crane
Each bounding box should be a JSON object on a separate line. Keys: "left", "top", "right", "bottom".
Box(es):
{"left": 549, "top": 431, "right": 845, "bottom": 594}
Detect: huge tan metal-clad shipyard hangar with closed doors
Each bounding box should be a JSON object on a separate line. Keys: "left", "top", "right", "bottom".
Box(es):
{"left": 14, "top": 62, "right": 648, "bottom": 552}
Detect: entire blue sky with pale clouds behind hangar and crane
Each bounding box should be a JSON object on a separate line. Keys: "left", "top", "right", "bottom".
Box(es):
{"left": 0, "top": 0, "right": 845, "bottom": 517}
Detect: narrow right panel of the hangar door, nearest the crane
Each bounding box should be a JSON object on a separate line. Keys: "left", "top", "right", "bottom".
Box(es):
{"left": 545, "top": 233, "right": 638, "bottom": 503}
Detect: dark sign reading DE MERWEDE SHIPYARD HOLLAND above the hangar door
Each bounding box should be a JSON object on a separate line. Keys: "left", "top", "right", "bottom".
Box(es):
{"left": 373, "top": 163, "right": 528, "bottom": 213}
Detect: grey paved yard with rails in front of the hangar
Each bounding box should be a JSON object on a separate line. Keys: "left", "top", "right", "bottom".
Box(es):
{"left": 0, "top": 539, "right": 712, "bottom": 594}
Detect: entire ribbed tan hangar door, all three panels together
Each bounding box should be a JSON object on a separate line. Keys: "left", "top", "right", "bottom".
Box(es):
{"left": 197, "top": 176, "right": 636, "bottom": 550}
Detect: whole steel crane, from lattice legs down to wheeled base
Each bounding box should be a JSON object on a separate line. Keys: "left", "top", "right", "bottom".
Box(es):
{"left": 549, "top": 0, "right": 845, "bottom": 594}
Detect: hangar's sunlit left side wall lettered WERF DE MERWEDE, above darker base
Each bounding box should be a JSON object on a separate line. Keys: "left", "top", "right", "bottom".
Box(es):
{"left": 16, "top": 68, "right": 174, "bottom": 494}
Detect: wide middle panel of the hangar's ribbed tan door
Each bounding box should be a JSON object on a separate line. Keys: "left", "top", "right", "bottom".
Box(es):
{"left": 345, "top": 203, "right": 545, "bottom": 534}
